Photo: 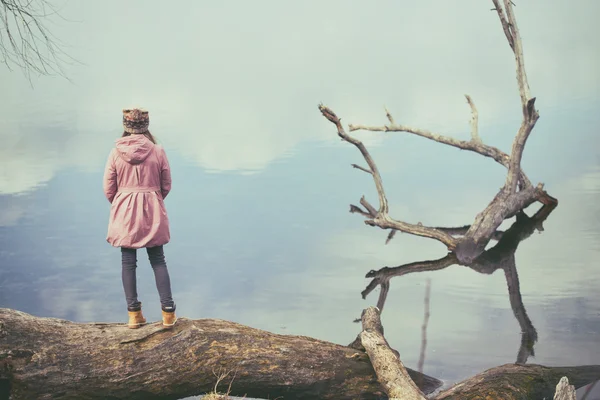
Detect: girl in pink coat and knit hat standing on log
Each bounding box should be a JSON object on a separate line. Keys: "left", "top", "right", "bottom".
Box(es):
{"left": 103, "top": 108, "right": 177, "bottom": 329}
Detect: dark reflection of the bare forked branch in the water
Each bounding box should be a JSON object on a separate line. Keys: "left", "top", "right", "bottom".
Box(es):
{"left": 355, "top": 204, "right": 556, "bottom": 364}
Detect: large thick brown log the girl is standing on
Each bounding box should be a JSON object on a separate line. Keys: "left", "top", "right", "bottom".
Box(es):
{"left": 0, "top": 308, "right": 441, "bottom": 400}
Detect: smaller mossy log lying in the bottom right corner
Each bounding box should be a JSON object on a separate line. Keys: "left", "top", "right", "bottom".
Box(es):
{"left": 435, "top": 364, "right": 600, "bottom": 400}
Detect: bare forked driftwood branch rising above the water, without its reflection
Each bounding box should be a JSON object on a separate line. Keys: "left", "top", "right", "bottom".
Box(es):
{"left": 319, "top": 0, "right": 557, "bottom": 265}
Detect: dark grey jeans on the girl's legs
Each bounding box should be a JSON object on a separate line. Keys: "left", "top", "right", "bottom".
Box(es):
{"left": 121, "top": 246, "right": 175, "bottom": 312}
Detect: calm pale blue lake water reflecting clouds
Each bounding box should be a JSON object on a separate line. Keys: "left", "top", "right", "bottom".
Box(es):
{"left": 0, "top": 0, "right": 600, "bottom": 396}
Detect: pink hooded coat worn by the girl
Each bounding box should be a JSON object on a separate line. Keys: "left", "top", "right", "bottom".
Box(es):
{"left": 103, "top": 134, "right": 171, "bottom": 249}
